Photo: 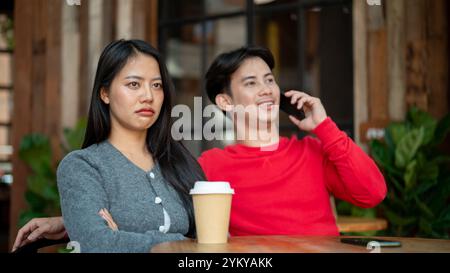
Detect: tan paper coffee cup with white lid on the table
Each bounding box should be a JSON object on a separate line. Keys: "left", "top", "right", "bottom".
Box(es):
{"left": 190, "top": 181, "right": 234, "bottom": 244}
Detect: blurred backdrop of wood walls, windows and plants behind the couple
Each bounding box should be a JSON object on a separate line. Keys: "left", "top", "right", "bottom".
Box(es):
{"left": 0, "top": 0, "right": 450, "bottom": 252}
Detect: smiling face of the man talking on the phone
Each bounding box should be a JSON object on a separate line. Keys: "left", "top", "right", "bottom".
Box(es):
{"left": 230, "top": 57, "right": 280, "bottom": 122}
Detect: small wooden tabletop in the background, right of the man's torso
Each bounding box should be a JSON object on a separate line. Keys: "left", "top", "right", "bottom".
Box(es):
{"left": 336, "top": 216, "right": 387, "bottom": 232}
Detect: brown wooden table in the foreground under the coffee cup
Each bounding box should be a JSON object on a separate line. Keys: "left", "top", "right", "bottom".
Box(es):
{"left": 151, "top": 236, "right": 450, "bottom": 253}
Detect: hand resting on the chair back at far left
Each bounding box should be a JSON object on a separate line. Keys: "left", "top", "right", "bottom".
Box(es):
{"left": 12, "top": 217, "right": 67, "bottom": 251}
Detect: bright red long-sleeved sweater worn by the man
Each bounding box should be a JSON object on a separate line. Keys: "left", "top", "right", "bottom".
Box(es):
{"left": 198, "top": 118, "right": 386, "bottom": 236}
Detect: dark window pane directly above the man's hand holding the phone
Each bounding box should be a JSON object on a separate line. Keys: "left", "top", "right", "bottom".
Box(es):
{"left": 303, "top": 6, "right": 353, "bottom": 137}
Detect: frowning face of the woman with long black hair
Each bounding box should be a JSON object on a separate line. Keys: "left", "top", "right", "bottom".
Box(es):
{"left": 101, "top": 53, "right": 164, "bottom": 131}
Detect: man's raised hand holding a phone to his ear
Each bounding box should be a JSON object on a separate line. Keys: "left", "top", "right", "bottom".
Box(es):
{"left": 281, "top": 90, "right": 327, "bottom": 132}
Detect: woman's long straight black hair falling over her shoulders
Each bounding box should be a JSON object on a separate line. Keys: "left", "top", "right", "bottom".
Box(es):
{"left": 82, "top": 40, "right": 205, "bottom": 237}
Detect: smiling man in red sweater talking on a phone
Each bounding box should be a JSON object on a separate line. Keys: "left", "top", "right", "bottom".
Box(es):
{"left": 14, "top": 47, "right": 386, "bottom": 251}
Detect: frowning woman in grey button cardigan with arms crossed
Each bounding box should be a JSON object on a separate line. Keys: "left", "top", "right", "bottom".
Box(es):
{"left": 15, "top": 40, "right": 204, "bottom": 252}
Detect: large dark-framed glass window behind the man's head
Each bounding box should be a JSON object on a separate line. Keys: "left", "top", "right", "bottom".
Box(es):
{"left": 159, "top": 0, "right": 353, "bottom": 155}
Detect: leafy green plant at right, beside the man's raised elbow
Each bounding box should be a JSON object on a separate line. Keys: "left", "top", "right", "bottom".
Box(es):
{"left": 369, "top": 108, "right": 450, "bottom": 238}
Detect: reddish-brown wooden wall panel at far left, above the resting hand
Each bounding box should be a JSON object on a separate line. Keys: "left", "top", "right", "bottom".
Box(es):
{"left": 10, "top": 0, "right": 62, "bottom": 244}
